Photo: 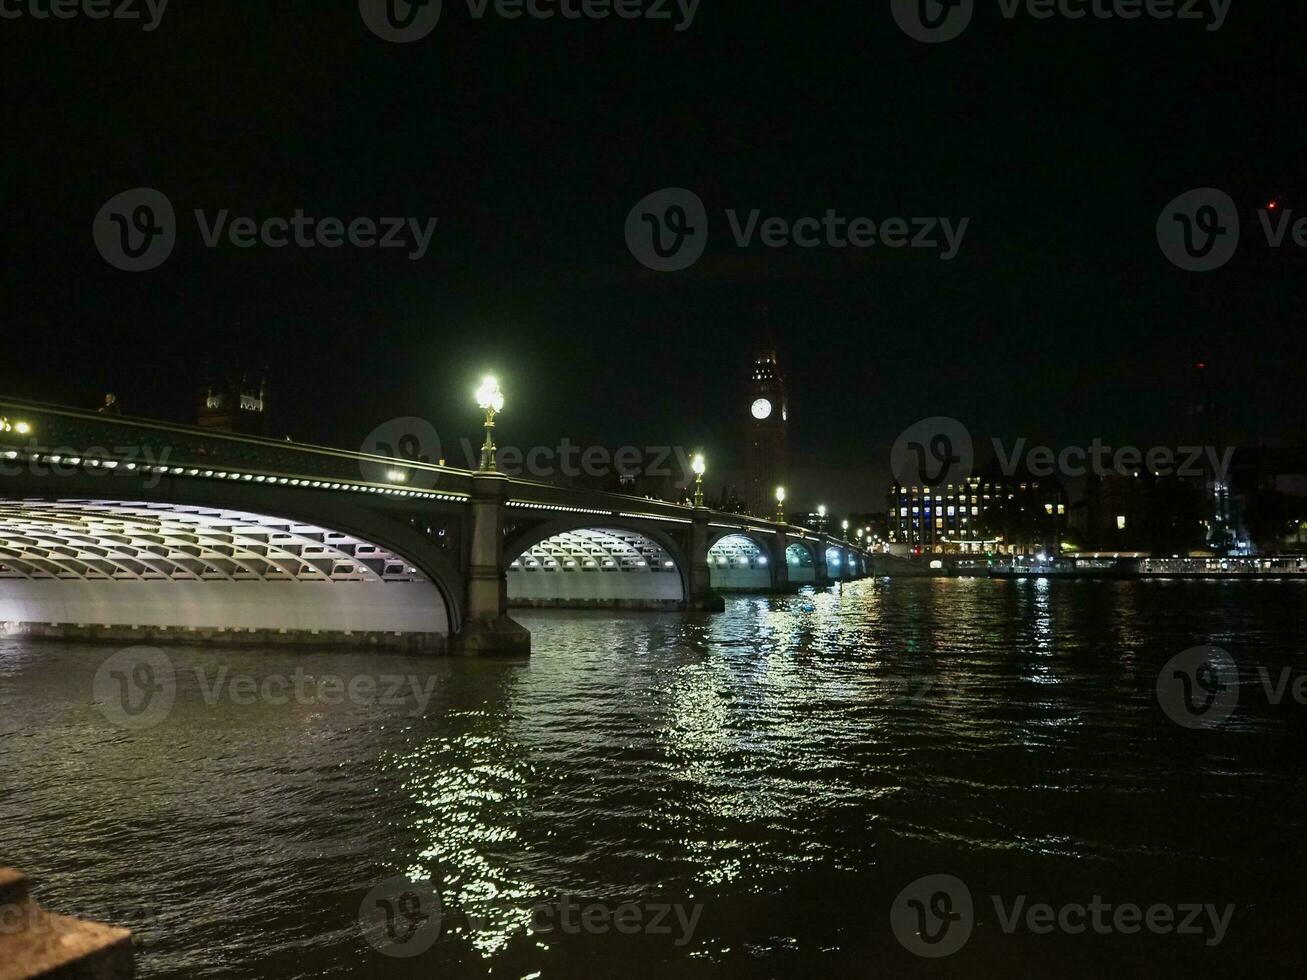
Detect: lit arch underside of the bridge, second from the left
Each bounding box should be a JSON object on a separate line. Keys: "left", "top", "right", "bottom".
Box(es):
{"left": 508, "top": 528, "right": 685, "bottom": 606}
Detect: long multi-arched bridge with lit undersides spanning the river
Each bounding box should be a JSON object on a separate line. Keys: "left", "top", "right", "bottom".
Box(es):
{"left": 0, "top": 399, "right": 868, "bottom": 653}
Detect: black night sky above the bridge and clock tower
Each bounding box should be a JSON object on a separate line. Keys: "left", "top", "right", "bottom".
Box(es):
{"left": 0, "top": 0, "right": 1307, "bottom": 510}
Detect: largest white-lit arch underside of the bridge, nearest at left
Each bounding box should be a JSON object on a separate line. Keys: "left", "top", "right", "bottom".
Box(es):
{"left": 0, "top": 500, "right": 448, "bottom": 635}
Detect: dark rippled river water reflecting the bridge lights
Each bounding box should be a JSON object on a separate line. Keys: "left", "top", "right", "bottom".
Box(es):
{"left": 0, "top": 580, "right": 1307, "bottom": 977}
